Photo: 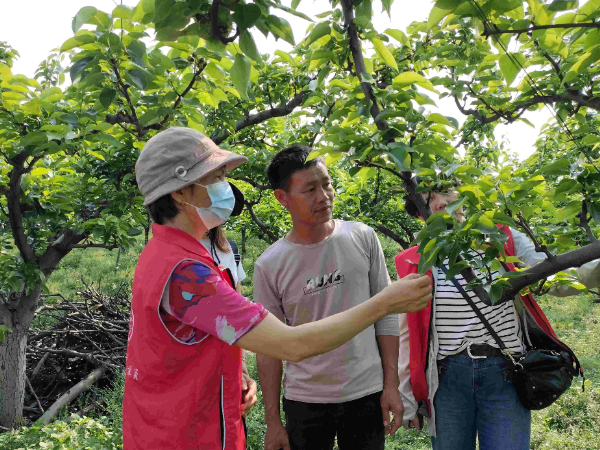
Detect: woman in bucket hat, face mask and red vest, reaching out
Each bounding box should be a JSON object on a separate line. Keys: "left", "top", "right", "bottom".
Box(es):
{"left": 123, "top": 127, "right": 431, "bottom": 450}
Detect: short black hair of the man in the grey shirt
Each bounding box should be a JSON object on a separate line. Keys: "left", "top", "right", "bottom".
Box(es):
{"left": 267, "top": 144, "right": 322, "bottom": 191}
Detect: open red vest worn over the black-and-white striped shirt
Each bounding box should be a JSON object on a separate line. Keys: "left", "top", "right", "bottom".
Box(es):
{"left": 394, "top": 225, "right": 558, "bottom": 411}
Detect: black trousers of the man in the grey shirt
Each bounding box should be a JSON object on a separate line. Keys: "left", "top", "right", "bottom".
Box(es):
{"left": 283, "top": 392, "right": 385, "bottom": 450}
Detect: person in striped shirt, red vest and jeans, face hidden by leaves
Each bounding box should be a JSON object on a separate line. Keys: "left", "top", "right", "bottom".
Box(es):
{"left": 395, "top": 183, "right": 600, "bottom": 450}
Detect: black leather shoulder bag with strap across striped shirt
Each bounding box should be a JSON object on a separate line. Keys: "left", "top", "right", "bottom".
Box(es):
{"left": 442, "top": 265, "right": 581, "bottom": 410}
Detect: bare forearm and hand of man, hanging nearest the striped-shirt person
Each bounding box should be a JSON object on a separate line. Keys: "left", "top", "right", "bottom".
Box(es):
{"left": 377, "top": 335, "right": 404, "bottom": 435}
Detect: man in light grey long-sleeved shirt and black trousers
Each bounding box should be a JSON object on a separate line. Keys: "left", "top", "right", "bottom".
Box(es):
{"left": 254, "top": 145, "right": 403, "bottom": 450}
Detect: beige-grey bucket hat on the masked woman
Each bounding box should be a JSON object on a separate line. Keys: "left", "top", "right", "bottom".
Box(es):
{"left": 135, "top": 127, "right": 248, "bottom": 205}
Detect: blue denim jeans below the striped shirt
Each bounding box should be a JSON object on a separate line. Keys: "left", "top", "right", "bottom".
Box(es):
{"left": 431, "top": 355, "right": 531, "bottom": 450}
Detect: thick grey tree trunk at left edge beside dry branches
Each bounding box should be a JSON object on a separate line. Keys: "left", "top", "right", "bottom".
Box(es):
{"left": 0, "top": 326, "right": 27, "bottom": 428}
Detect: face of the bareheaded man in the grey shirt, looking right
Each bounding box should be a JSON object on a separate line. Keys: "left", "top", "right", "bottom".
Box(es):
{"left": 275, "top": 162, "right": 335, "bottom": 225}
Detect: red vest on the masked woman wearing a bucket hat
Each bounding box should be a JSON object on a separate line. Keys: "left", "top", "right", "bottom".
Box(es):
{"left": 123, "top": 224, "right": 246, "bottom": 450}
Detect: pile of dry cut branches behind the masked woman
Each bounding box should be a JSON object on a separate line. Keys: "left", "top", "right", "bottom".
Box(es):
{"left": 24, "top": 283, "right": 130, "bottom": 423}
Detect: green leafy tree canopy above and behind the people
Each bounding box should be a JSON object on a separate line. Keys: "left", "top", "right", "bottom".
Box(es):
{"left": 0, "top": 0, "right": 600, "bottom": 425}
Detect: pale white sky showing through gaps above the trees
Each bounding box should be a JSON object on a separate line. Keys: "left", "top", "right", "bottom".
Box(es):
{"left": 0, "top": 0, "right": 552, "bottom": 159}
